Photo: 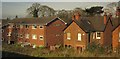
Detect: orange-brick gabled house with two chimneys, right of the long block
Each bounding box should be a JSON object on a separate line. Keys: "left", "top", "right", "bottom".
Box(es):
{"left": 64, "top": 11, "right": 112, "bottom": 51}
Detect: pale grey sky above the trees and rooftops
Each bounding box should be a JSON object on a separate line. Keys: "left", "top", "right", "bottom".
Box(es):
{"left": 0, "top": 0, "right": 117, "bottom": 18}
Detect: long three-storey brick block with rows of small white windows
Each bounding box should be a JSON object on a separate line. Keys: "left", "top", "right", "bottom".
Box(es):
{"left": 4, "top": 17, "right": 69, "bottom": 47}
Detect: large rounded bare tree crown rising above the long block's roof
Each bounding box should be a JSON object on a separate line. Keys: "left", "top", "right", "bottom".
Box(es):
{"left": 27, "top": 3, "right": 55, "bottom": 17}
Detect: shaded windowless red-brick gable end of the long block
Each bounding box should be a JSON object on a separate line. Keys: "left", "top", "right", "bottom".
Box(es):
{"left": 45, "top": 19, "right": 66, "bottom": 47}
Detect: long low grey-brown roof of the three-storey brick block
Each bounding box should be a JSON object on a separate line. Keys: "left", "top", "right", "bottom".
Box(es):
{"left": 10, "top": 16, "right": 71, "bottom": 25}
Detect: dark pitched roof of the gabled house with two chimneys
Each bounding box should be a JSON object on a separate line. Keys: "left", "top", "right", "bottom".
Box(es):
{"left": 64, "top": 16, "right": 109, "bottom": 32}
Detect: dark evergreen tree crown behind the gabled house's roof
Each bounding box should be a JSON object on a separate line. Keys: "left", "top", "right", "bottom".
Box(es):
{"left": 85, "top": 6, "right": 103, "bottom": 16}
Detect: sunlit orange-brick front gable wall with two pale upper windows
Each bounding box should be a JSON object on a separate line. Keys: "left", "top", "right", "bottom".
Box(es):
{"left": 64, "top": 22, "right": 87, "bottom": 49}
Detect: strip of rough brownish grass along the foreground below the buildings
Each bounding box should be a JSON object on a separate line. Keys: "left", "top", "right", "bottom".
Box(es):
{"left": 2, "top": 43, "right": 120, "bottom": 57}
